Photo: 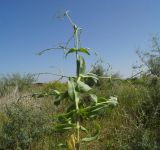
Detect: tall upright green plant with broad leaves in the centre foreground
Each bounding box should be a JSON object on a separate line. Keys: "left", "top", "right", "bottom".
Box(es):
{"left": 37, "top": 11, "right": 117, "bottom": 150}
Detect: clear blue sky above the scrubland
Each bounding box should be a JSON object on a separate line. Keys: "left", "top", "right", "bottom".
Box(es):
{"left": 0, "top": 0, "right": 160, "bottom": 81}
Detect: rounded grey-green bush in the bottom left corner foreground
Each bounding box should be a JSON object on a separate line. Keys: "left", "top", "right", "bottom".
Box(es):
{"left": 0, "top": 103, "right": 50, "bottom": 149}
